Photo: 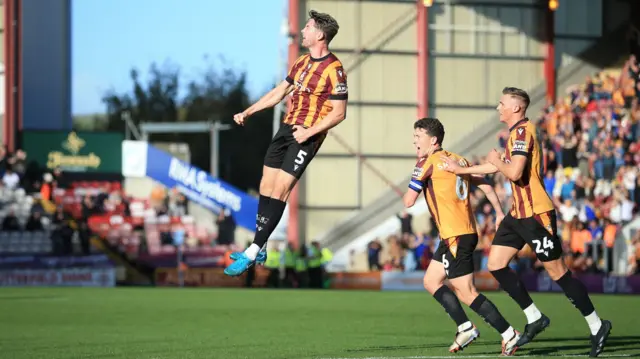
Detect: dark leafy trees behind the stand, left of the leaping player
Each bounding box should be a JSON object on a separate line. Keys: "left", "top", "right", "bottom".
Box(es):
{"left": 103, "top": 61, "right": 273, "bottom": 191}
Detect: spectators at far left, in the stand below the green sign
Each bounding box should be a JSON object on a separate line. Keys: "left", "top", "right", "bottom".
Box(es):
{"left": 0, "top": 146, "right": 141, "bottom": 255}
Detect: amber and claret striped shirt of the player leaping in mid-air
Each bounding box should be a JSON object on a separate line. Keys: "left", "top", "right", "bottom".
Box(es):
{"left": 284, "top": 53, "right": 348, "bottom": 127}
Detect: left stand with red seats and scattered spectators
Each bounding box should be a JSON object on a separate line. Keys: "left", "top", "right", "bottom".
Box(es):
{"left": 0, "top": 150, "right": 222, "bottom": 258}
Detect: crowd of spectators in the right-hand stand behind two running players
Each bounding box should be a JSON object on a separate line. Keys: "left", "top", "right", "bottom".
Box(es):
{"left": 367, "top": 55, "right": 640, "bottom": 274}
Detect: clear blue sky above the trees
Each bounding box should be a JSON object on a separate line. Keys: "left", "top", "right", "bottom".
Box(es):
{"left": 72, "top": 0, "right": 286, "bottom": 115}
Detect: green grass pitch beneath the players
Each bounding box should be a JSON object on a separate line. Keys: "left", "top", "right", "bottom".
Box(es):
{"left": 0, "top": 288, "right": 640, "bottom": 359}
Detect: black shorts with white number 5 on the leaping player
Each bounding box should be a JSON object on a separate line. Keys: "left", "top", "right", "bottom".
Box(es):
{"left": 264, "top": 124, "right": 327, "bottom": 179}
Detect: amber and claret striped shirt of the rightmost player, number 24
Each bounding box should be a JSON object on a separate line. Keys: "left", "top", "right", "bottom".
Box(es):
{"left": 505, "top": 119, "right": 554, "bottom": 219}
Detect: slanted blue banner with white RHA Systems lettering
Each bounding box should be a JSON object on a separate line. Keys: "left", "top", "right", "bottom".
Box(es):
{"left": 146, "top": 145, "right": 258, "bottom": 231}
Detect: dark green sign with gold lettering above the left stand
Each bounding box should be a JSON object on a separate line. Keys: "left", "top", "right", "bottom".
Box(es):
{"left": 22, "top": 131, "right": 124, "bottom": 173}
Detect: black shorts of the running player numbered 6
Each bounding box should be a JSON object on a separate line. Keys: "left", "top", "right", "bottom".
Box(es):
{"left": 433, "top": 233, "right": 478, "bottom": 279}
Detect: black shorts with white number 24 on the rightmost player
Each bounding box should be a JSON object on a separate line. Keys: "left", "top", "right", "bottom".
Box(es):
{"left": 491, "top": 210, "right": 562, "bottom": 262}
